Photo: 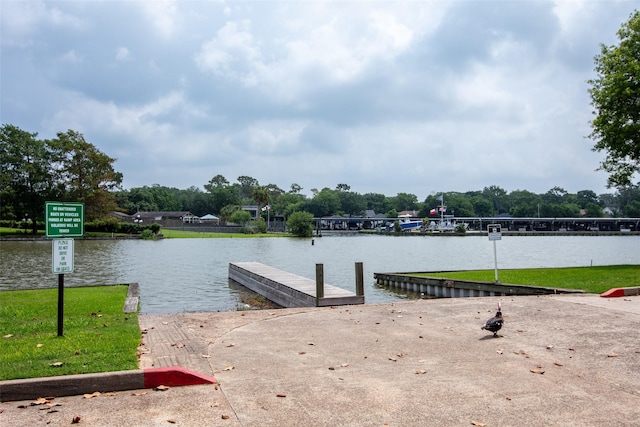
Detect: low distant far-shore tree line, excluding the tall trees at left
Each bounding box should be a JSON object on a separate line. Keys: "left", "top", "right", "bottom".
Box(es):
{"left": 115, "top": 181, "right": 640, "bottom": 220}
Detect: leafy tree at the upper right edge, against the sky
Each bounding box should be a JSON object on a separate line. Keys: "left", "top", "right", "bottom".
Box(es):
{"left": 588, "top": 11, "right": 640, "bottom": 187}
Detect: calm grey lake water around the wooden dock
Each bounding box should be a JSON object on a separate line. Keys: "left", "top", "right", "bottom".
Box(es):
{"left": 0, "top": 235, "right": 640, "bottom": 314}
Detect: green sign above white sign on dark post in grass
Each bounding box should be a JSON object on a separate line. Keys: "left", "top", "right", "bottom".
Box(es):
{"left": 45, "top": 202, "right": 84, "bottom": 337}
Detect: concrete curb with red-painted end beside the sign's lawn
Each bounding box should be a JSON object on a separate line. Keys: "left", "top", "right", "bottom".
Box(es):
{"left": 0, "top": 366, "right": 217, "bottom": 402}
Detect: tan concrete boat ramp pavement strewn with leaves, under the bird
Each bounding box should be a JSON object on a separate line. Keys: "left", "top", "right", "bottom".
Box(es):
{"left": 0, "top": 295, "right": 640, "bottom": 426}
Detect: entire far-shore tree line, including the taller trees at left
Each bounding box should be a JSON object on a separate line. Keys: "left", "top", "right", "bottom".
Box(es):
{"left": 0, "top": 125, "right": 640, "bottom": 236}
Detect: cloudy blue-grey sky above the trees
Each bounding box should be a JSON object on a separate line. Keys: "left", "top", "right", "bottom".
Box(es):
{"left": 0, "top": 0, "right": 638, "bottom": 200}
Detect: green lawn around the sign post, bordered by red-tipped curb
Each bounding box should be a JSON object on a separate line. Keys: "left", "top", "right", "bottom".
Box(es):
{"left": 0, "top": 285, "right": 140, "bottom": 380}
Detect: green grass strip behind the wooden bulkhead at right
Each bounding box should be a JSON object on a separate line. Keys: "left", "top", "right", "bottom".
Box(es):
{"left": 416, "top": 265, "right": 640, "bottom": 294}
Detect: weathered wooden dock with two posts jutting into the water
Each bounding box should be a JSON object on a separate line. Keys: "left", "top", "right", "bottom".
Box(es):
{"left": 229, "top": 262, "right": 364, "bottom": 307}
